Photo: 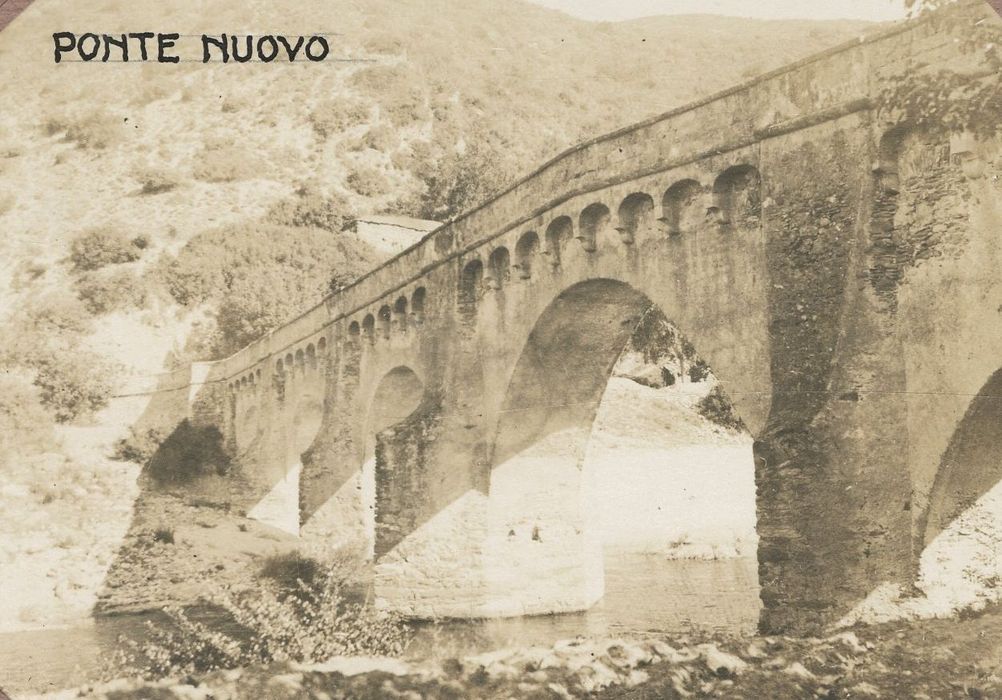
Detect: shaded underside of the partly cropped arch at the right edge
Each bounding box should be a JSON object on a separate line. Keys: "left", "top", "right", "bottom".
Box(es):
{"left": 918, "top": 369, "right": 1002, "bottom": 547}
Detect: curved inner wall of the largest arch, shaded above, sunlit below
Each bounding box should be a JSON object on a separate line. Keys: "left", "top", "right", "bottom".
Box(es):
{"left": 485, "top": 278, "right": 757, "bottom": 615}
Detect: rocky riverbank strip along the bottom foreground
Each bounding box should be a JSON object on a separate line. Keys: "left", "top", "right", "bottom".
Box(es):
{"left": 31, "top": 609, "right": 1002, "bottom": 700}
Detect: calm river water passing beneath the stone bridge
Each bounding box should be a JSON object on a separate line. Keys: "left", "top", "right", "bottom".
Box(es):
{"left": 0, "top": 553, "right": 760, "bottom": 700}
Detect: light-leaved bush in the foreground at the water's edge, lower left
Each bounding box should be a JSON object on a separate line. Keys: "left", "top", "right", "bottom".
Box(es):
{"left": 106, "top": 552, "right": 411, "bottom": 678}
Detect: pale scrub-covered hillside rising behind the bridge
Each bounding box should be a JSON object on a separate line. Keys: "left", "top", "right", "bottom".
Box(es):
{"left": 0, "top": 0, "right": 881, "bottom": 628}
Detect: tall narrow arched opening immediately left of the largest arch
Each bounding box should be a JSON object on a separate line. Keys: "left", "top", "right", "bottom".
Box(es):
{"left": 370, "top": 367, "right": 425, "bottom": 557}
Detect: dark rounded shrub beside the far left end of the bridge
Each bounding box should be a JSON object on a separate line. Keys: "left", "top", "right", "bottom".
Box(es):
{"left": 147, "top": 419, "right": 230, "bottom": 484}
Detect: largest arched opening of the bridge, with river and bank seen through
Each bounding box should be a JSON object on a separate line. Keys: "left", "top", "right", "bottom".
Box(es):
{"left": 487, "top": 279, "right": 760, "bottom": 632}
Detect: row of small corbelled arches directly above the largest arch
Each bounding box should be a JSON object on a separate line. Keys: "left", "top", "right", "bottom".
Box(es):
{"left": 459, "top": 164, "right": 762, "bottom": 310}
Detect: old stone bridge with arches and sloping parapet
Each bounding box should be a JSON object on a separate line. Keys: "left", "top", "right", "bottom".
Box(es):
{"left": 146, "top": 4, "right": 1002, "bottom": 631}
